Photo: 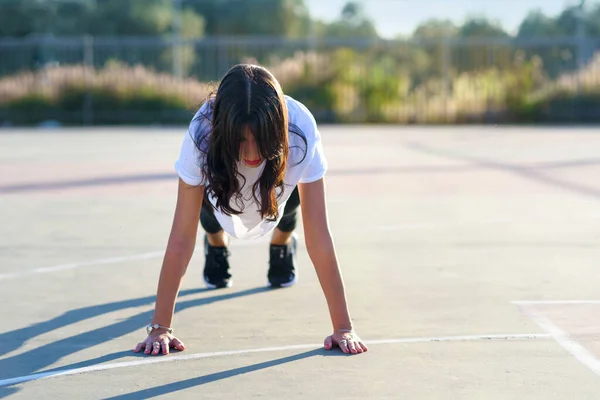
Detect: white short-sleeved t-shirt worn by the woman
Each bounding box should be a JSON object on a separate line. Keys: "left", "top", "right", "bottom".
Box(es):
{"left": 175, "top": 96, "right": 327, "bottom": 239}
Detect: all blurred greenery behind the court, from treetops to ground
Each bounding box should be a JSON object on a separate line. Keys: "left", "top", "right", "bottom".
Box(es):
{"left": 0, "top": 0, "right": 600, "bottom": 124}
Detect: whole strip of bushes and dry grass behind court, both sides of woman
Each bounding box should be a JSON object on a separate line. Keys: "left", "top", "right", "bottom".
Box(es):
{"left": 0, "top": 48, "right": 600, "bottom": 125}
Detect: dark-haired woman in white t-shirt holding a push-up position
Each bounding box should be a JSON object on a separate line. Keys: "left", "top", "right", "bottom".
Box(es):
{"left": 134, "top": 64, "right": 367, "bottom": 355}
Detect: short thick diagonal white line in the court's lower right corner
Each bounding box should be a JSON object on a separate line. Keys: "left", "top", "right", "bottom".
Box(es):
{"left": 520, "top": 304, "right": 600, "bottom": 375}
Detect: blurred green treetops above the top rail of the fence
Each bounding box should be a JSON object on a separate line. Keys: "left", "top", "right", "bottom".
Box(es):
{"left": 0, "top": 0, "right": 600, "bottom": 39}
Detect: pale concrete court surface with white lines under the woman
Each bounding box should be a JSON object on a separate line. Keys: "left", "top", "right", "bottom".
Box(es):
{"left": 0, "top": 126, "right": 600, "bottom": 399}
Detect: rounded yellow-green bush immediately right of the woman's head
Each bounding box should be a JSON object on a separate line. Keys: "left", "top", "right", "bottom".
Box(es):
{"left": 260, "top": 48, "right": 408, "bottom": 122}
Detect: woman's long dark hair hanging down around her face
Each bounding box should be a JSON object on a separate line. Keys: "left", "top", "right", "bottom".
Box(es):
{"left": 195, "top": 64, "right": 307, "bottom": 220}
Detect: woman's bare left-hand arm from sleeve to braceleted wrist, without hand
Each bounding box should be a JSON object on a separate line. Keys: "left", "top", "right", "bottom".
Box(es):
{"left": 152, "top": 179, "right": 204, "bottom": 327}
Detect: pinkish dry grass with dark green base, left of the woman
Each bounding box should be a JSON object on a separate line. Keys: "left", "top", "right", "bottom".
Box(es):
{"left": 0, "top": 63, "right": 212, "bottom": 125}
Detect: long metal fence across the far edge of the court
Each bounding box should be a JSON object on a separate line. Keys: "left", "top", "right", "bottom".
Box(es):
{"left": 0, "top": 37, "right": 600, "bottom": 124}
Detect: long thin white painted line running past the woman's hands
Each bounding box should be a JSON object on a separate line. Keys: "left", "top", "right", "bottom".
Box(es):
{"left": 0, "top": 333, "right": 551, "bottom": 387}
